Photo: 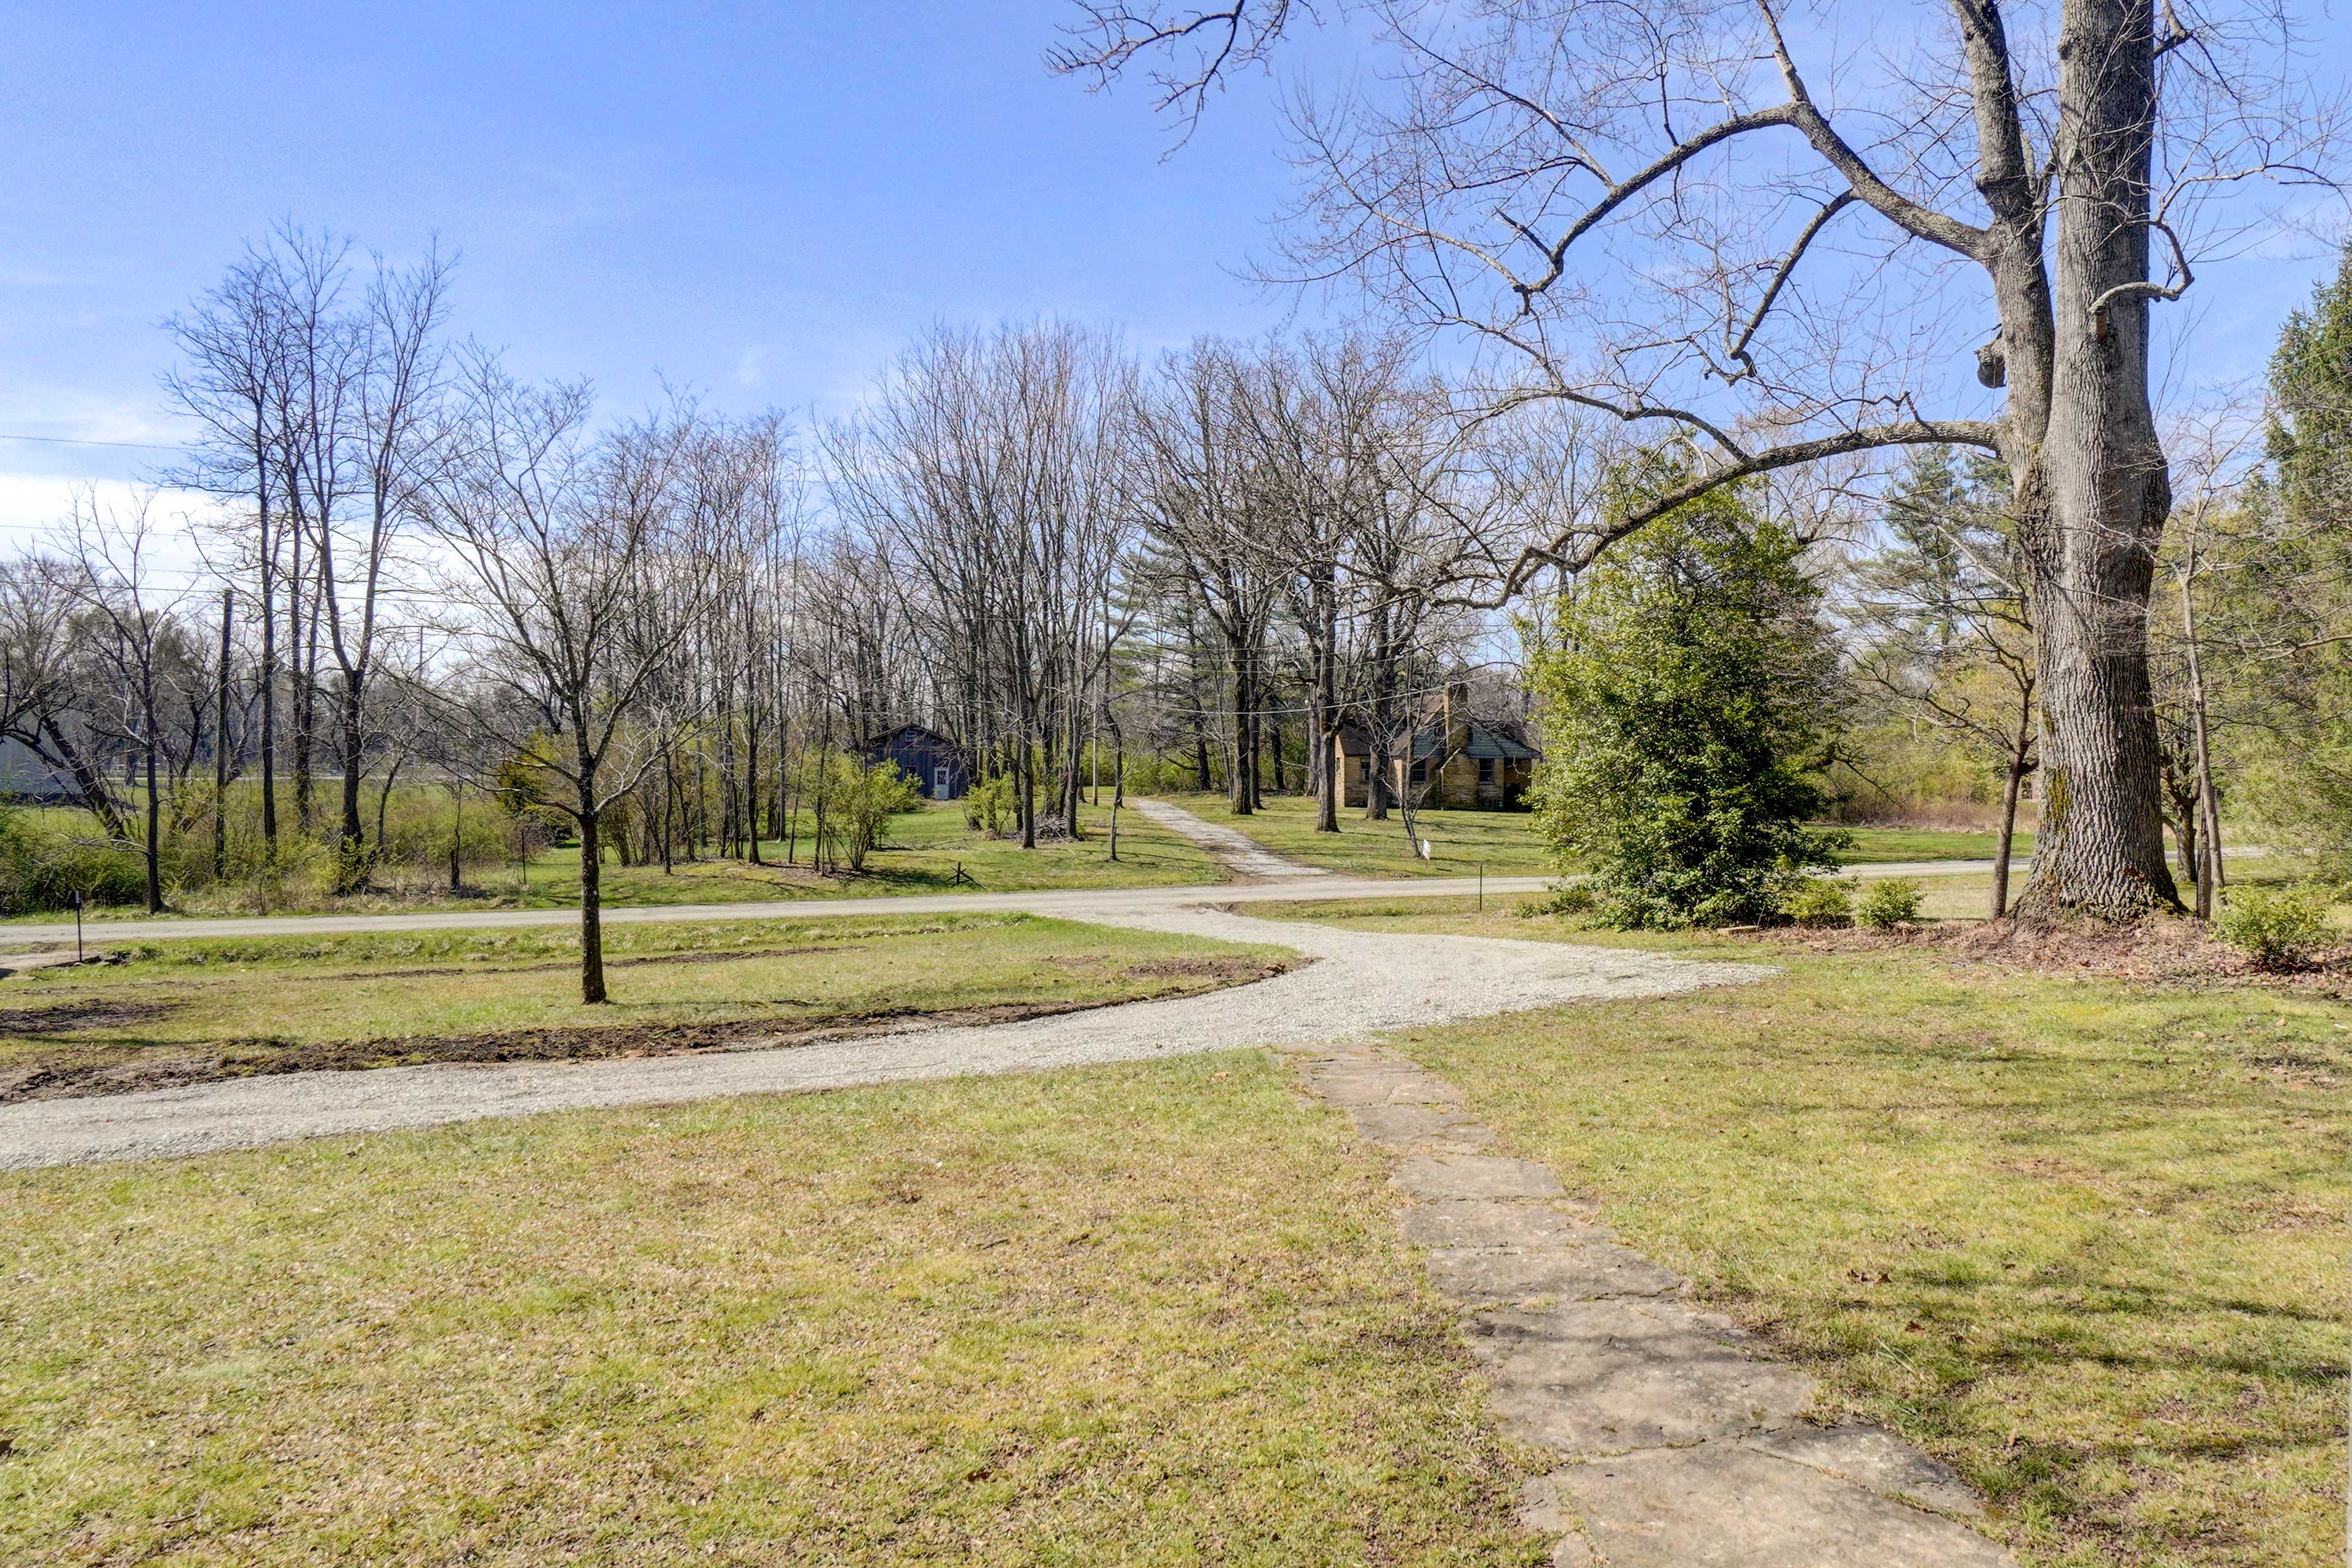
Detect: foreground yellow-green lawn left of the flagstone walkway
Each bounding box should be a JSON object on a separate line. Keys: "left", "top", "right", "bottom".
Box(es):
{"left": 0, "top": 1053, "right": 1543, "bottom": 1568}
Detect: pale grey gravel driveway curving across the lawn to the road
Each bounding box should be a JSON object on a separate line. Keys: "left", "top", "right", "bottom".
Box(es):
{"left": 0, "top": 902, "right": 1773, "bottom": 1169}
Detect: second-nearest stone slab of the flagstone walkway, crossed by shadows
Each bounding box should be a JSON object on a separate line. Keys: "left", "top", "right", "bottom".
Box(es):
{"left": 1465, "top": 1300, "right": 1815, "bottom": 1453}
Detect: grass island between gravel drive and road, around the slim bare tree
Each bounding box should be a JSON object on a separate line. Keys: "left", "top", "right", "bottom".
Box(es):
{"left": 0, "top": 912, "right": 1289, "bottom": 1098}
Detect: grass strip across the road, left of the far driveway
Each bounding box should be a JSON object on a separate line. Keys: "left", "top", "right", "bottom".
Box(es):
{"left": 23, "top": 802, "right": 1226, "bottom": 922}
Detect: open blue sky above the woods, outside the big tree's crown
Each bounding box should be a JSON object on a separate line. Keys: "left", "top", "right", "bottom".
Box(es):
{"left": 0, "top": 0, "right": 2343, "bottom": 536}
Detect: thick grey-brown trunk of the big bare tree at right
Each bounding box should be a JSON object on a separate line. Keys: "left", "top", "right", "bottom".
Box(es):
{"left": 1988, "top": 0, "right": 2180, "bottom": 919}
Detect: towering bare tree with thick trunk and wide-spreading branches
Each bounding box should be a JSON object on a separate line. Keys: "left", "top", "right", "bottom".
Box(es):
{"left": 1058, "top": 0, "right": 2343, "bottom": 919}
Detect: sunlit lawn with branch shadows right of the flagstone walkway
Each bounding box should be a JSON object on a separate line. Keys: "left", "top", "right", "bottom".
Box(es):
{"left": 1256, "top": 905, "right": 2352, "bottom": 1568}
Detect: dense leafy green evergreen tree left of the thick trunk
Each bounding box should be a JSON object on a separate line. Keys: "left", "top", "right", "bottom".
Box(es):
{"left": 1531, "top": 470, "right": 1844, "bottom": 929}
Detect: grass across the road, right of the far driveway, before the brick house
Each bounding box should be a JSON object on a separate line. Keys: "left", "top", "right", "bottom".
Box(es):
{"left": 1138, "top": 794, "right": 2035, "bottom": 877}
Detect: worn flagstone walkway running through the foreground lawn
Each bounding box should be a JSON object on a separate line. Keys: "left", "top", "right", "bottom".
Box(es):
{"left": 1291, "top": 1044, "right": 2013, "bottom": 1568}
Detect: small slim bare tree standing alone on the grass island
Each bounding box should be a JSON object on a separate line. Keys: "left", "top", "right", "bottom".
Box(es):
{"left": 414, "top": 360, "right": 717, "bottom": 1001}
